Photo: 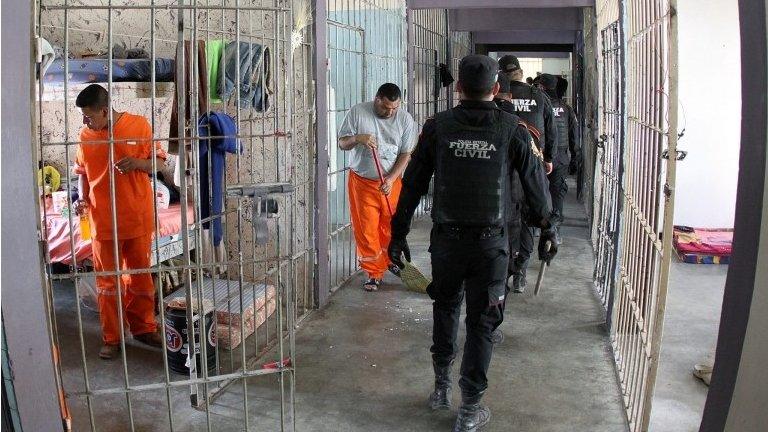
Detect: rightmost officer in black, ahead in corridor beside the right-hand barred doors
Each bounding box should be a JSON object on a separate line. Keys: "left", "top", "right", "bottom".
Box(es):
{"left": 541, "top": 74, "right": 581, "bottom": 244}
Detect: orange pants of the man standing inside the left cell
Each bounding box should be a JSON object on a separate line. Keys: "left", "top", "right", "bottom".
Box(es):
{"left": 93, "top": 234, "right": 157, "bottom": 345}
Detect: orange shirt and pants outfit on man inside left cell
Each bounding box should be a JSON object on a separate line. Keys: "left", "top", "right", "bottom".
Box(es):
{"left": 76, "top": 113, "right": 165, "bottom": 345}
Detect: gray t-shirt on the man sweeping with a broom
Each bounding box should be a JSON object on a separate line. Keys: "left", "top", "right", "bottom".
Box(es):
{"left": 339, "top": 102, "right": 417, "bottom": 179}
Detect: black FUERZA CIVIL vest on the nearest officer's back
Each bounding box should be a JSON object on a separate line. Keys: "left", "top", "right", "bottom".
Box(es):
{"left": 432, "top": 109, "right": 517, "bottom": 226}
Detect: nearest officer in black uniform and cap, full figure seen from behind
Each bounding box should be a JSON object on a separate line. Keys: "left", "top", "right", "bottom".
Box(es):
{"left": 388, "top": 55, "right": 557, "bottom": 432}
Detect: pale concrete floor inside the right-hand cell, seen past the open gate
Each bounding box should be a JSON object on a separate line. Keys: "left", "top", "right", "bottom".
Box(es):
{"left": 650, "top": 262, "right": 728, "bottom": 432}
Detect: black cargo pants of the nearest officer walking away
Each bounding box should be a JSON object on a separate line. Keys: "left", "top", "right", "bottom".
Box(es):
{"left": 427, "top": 225, "right": 509, "bottom": 396}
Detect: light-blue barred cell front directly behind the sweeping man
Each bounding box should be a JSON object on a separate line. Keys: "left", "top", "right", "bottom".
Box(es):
{"left": 323, "top": 0, "right": 406, "bottom": 291}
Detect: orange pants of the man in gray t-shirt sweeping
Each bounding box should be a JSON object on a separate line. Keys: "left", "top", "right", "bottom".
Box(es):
{"left": 349, "top": 171, "right": 402, "bottom": 279}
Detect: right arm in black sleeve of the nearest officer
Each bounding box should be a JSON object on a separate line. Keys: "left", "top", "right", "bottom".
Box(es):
{"left": 511, "top": 126, "right": 552, "bottom": 229}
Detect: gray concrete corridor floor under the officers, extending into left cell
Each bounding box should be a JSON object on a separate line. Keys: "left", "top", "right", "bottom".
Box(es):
{"left": 56, "top": 186, "right": 627, "bottom": 432}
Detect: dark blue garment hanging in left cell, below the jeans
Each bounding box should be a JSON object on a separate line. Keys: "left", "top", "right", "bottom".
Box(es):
{"left": 197, "top": 111, "right": 243, "bottom": 246}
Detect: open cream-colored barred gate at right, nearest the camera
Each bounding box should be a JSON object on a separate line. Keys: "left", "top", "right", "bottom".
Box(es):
{"left": 595, "top": 0, "right": 677, "bottom": 432}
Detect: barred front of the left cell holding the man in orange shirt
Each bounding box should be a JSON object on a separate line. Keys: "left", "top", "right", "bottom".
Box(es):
{"left": 34, "top": 0, "right": 315, "bottom": 431}
